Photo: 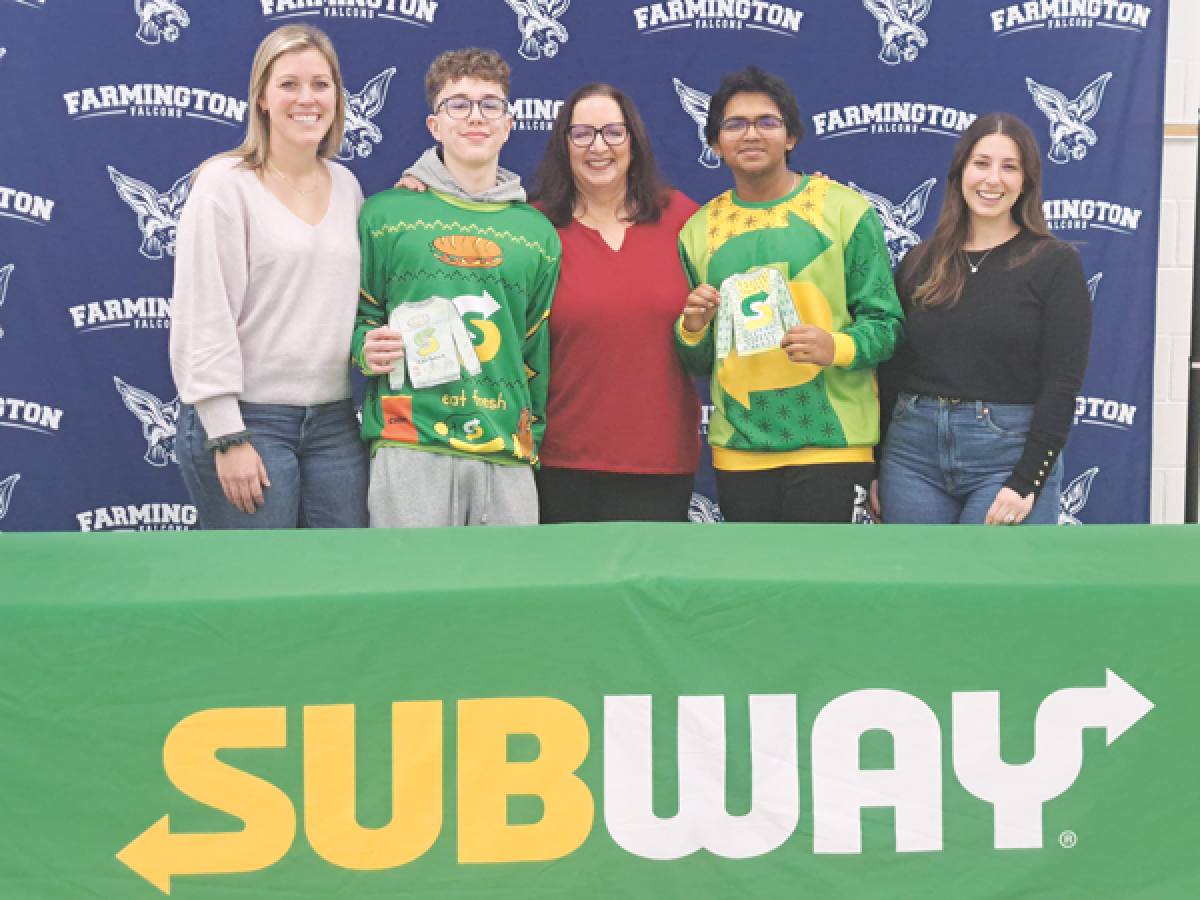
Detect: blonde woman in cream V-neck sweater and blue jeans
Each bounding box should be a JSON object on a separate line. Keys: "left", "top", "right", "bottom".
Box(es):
{"left": 170, "top": 25, "right": 367, "bottom": 528}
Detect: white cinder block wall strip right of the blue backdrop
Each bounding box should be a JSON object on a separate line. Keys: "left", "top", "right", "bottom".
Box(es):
{"left": 1150, "top": 0, "right": 1200, "bottom": 523}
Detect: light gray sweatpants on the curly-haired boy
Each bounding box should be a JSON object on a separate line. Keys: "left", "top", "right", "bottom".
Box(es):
{"left": 367, "top": 446, "right": 538, "bottom": 528}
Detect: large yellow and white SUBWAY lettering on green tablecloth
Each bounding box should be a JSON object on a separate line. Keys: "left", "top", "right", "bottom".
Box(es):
{"left": 116, "top": 670, "right": 1154, "bottom": 893}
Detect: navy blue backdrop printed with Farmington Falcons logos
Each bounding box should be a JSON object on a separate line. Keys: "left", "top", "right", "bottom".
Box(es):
{"left": 0, "top": 0, "right": 1168, "bottom": 530}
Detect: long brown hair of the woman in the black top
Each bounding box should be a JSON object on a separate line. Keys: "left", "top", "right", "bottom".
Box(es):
{"left": 906, "top": 113, "right": 1054, "bottom": 310}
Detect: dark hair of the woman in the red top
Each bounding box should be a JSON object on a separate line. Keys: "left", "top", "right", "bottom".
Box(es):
{"left": 529, "top": 82, "right": 671, "bottom": 228}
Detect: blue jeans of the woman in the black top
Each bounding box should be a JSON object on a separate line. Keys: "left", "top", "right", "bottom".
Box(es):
{"left": 880, "top": 394, "right": 1062, "bottom": 524}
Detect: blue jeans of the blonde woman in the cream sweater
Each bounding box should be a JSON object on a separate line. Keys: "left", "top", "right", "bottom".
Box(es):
{"left": 175, "top": 400, "right": 367, "bottom": 529}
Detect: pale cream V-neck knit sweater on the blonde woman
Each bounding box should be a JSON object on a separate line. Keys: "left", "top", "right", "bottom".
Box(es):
{"left": 170, "top": 158, "right": 362, "bottom": 438}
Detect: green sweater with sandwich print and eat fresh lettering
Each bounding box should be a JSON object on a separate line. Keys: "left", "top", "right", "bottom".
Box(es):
{"left": 353, "top": 188, "right": 562, "bottom": 466}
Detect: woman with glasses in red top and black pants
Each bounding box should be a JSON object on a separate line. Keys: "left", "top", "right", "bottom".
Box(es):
{"left": 533, "top": 83, "right": 700, "bottom": 524}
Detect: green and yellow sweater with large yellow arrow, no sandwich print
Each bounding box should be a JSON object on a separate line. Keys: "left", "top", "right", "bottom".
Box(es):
{"left": 676, "top": 176, "right": 904, "bottom": 472}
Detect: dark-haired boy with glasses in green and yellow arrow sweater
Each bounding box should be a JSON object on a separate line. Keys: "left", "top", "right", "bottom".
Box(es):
{"left": 676, "top": 66, "right": 902, "bottom": 522}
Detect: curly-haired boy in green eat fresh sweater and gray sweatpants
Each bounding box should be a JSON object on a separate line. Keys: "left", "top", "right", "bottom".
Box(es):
{"left": 353, "top": 48, "right": 559, "bottom": 528}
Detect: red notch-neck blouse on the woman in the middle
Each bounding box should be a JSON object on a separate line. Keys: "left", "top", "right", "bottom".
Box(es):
{"left": 541, "top": 191, "right": 700, "bottom": 475}
